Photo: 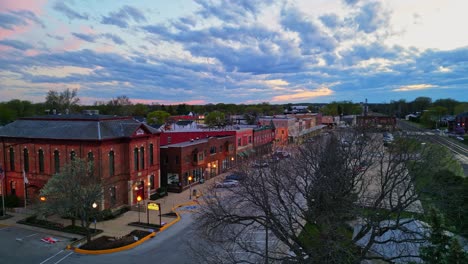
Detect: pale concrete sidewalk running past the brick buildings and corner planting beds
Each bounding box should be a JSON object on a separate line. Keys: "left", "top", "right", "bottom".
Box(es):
{"left": 0, "top": 173, "right": 227, "bottom": 238}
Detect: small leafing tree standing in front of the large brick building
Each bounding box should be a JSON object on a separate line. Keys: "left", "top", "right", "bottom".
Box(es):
{"left": 40, "top": 158, "right": 103, "bottom": 242}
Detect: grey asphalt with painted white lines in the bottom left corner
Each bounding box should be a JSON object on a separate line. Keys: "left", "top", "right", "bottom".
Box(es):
{"left": 0, "top": 225, "right": 73, "bottom": 264}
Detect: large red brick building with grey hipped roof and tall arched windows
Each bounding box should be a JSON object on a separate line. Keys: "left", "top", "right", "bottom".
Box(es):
{"left": 0, "top": 114, "right": 160, "bottom": 208}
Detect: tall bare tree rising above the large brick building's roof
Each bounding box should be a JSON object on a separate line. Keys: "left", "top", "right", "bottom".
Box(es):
{"left": 45, "top": 88, "right": 80, "bottom": 113}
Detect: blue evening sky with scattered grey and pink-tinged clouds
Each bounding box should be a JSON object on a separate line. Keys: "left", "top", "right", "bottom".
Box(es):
{"left": 0, "top": 0, "right": 468, "bottom": 105}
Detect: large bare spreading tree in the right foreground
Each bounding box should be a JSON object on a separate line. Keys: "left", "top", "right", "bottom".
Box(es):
{"left": 193, "top": 131, "right": 440, "bottom": 263}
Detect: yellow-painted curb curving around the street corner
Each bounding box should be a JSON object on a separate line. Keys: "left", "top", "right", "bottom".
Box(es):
{"left": 67, "top": 201, "right": 197, "bottom": 255}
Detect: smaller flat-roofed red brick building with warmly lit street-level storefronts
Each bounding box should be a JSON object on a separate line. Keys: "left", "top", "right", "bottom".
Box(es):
{"left": 161, "top": 135, "right": 236, "bottom": 192}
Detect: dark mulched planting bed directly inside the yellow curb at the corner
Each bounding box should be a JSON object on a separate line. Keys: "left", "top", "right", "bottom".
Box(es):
{"left": 79, "top": 230, "right": 153, "bottom": 251}
